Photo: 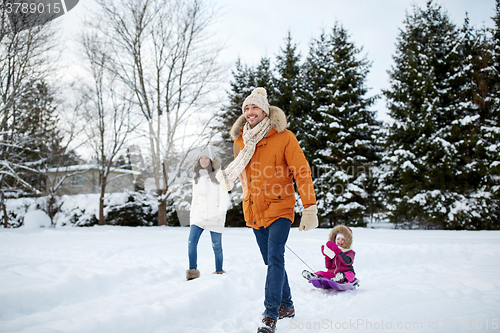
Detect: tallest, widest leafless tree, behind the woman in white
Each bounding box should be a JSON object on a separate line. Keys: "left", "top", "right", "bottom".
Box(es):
{"left": 93, "top": 0, "right": 223, "bottom": 225}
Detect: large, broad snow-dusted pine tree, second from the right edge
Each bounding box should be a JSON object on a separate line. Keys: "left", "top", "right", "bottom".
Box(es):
{"left": 383, "top": 1, "right": 490, "bottom": 228}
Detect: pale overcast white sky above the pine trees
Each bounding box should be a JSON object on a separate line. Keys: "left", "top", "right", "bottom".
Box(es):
{"left": 55, "top": 0, "right": 495, "bottom": 121}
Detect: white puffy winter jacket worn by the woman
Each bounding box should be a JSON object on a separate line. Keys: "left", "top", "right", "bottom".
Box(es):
{"left": 189, "top": 170, "right": 229, "bottom": 233}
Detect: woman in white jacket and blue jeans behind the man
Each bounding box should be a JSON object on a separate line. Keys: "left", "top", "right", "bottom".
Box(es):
{"left": 186, "top": 150, "right": 229, "bottom": 280}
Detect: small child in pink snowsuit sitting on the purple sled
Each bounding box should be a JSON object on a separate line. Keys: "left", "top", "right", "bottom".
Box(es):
{"left": 303, "top": 225, "right": 356, "bottom": 283}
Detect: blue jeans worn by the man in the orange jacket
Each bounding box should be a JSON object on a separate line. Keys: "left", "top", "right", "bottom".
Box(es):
{"left": 253, "top": 218, "right": 293, "bottom": 319}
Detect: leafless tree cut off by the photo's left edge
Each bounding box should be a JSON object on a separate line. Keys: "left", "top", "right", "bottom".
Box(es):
{"left": 0, "top": 3, "right": 56, "bottom": 227}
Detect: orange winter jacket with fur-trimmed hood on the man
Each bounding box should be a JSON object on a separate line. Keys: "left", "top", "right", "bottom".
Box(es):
{"left": 231, "top": 106, "right": 316, "bottom": 229}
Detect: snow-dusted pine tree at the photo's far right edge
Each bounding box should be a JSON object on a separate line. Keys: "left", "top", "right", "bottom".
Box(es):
{"left": 443, "top": 17, "right": 498, "bottom": 230}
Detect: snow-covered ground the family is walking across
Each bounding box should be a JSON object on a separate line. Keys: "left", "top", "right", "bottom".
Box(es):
{"left": 0, "top": 226, "right": 500, "bottom": 333}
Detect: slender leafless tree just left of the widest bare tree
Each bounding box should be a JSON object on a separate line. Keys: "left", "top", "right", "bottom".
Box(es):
{"left": 82, "top": 34, "right": 139, "bottom": 225}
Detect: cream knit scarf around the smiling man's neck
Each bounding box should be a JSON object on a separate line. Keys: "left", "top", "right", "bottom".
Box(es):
{"left": 215, "top": 117, "right": 271, "bottom": 191}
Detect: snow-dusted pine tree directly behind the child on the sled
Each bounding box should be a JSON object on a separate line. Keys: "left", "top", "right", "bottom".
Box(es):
{"left": 301, "top": 23, "right": 380, "bottom": 226}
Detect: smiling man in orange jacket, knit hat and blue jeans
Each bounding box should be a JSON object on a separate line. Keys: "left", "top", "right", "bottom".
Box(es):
{"left": 217, "top": 88, "right": 318, "bottom": 333}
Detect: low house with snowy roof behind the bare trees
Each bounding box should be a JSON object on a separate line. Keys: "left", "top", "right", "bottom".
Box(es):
{"left": 48, "top": 164, "right": 141, "bottom": 195}
